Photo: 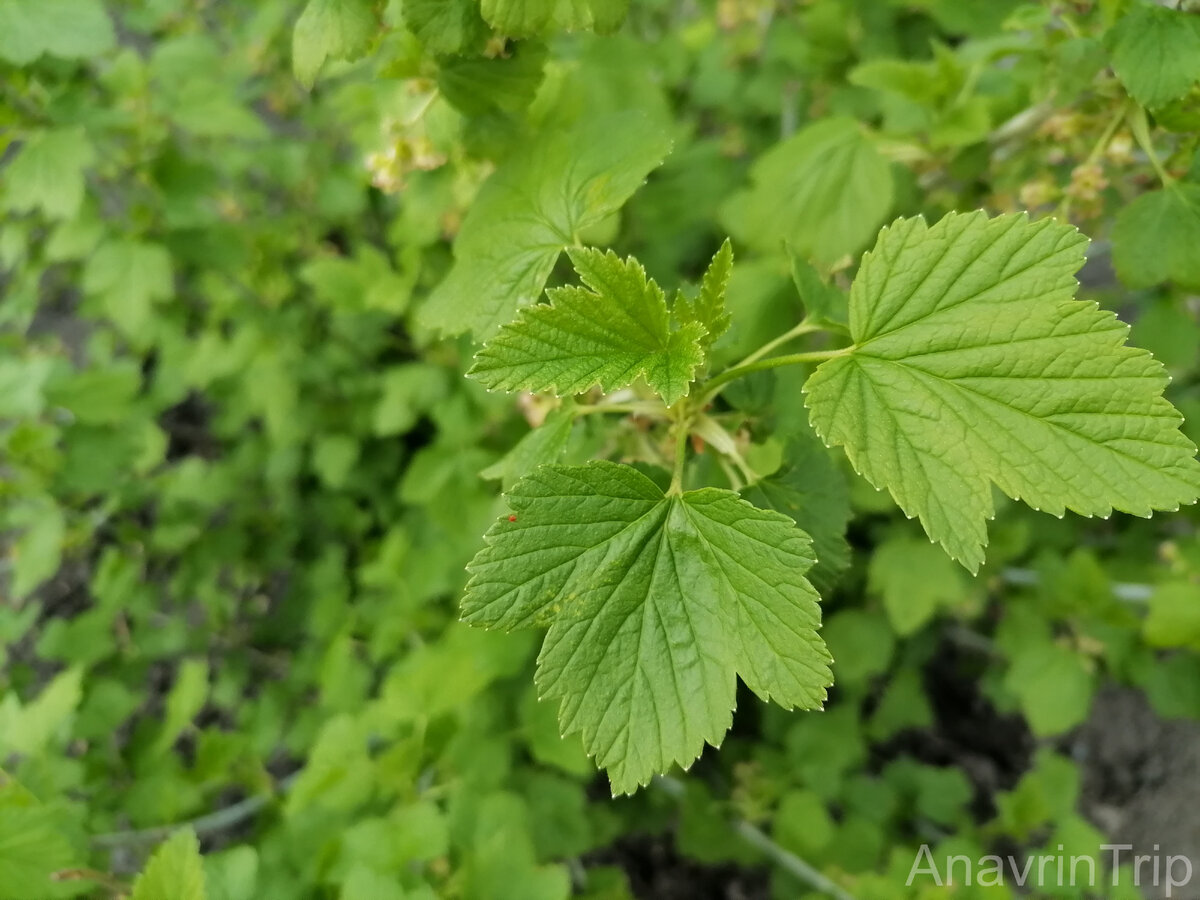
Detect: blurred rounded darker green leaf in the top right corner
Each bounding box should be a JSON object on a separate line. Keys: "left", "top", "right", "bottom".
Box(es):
{"left": 1109, "top": 4, "right": 1200, "bottom": 109}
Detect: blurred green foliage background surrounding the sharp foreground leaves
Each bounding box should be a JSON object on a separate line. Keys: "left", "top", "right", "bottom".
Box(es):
{"left": 0, "top": 0, "right": 1200, "bottom": 900}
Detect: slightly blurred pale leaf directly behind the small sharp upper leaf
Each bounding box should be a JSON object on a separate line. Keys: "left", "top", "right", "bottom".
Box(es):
{"left": 419, "top": 112, "right": 671, "bottom": 337}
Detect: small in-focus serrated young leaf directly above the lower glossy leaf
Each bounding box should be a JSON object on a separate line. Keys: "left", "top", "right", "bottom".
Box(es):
{"left": 468, "top": 244, "right": 704, "bottom": 406}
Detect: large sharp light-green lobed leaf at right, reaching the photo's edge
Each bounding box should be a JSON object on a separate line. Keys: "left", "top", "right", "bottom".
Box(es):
{"left": 804, "top": 212, "right": 1200, "bottom": 571}
